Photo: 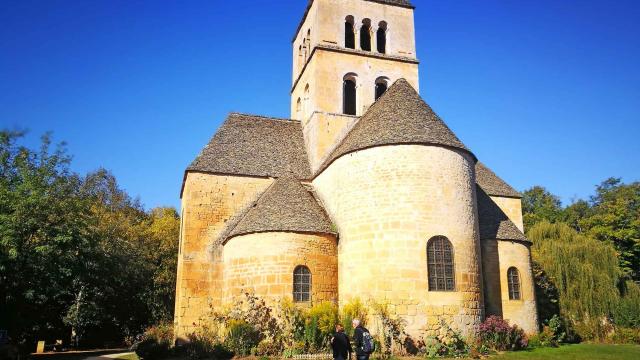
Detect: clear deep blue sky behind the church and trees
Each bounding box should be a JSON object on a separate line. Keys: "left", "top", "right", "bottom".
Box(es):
{"left": 0, "top": 0, "right": 640, "bottom": 208}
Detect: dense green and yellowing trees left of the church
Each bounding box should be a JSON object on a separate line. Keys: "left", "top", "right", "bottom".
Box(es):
{"left": 0, "top": 131, "right": 179, "bottom": 346}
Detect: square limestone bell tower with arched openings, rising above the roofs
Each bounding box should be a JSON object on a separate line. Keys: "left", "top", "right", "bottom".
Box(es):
{"left": 291, "top": 0, "right": 419, "bottom": 172}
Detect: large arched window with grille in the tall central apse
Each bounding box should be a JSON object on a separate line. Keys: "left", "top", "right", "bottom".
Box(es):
{"left": 427, "top": 236, "right": 456, "bottom": 291}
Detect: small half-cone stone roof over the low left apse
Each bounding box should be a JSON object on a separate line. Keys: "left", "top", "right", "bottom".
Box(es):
{"left": 225, "top": 177, "right": 335, "bottom": 239}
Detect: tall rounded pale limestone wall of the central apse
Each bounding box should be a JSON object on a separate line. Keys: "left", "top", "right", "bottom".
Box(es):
{"left": 313, "top": 145, "right": 484, "bottom": 335}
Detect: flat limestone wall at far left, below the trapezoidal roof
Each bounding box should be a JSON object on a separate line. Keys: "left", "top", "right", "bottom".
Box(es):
{"left": 174, "top": 173, "right": 273, "bottom": 337}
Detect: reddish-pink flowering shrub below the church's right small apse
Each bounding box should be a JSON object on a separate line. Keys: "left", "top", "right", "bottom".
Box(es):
{"left": 476, "top": 315, "right": 528, "bottom": 351}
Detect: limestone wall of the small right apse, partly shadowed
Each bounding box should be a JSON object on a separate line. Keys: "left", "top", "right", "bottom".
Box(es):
{"left": 482, "top": 240, "right": 538, "bottom": 334}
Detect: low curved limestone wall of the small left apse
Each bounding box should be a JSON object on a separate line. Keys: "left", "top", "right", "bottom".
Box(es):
{"left": 224, "top": 232, "right": 338, "bottom": 305}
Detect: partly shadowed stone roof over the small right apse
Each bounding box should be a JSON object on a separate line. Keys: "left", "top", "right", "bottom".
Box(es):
{"left": 476, "top": 186, "right": 529, "bottom": 242}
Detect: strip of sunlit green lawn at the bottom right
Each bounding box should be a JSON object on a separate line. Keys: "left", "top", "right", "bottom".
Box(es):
{"left": 489, "top": 344, "right": 640, "bottom": 360}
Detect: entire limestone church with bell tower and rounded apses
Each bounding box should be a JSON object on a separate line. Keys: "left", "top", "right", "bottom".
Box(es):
{"left": 175, "top": 0, "right": 537, "bottom": 336}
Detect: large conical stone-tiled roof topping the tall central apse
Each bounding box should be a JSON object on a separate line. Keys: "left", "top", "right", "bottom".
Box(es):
{"left": 319, "top": 79, "right": 475, "bottom": 172}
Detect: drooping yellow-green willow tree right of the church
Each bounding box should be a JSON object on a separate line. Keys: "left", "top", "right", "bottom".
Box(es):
{"left": 527, "top": 221, "right": 622, "bottom": 322}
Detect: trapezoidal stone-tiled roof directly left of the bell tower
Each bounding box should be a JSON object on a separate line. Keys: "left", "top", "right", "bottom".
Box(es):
{"left": 187, "top": 113, "right": 311, "bottom": 179}
